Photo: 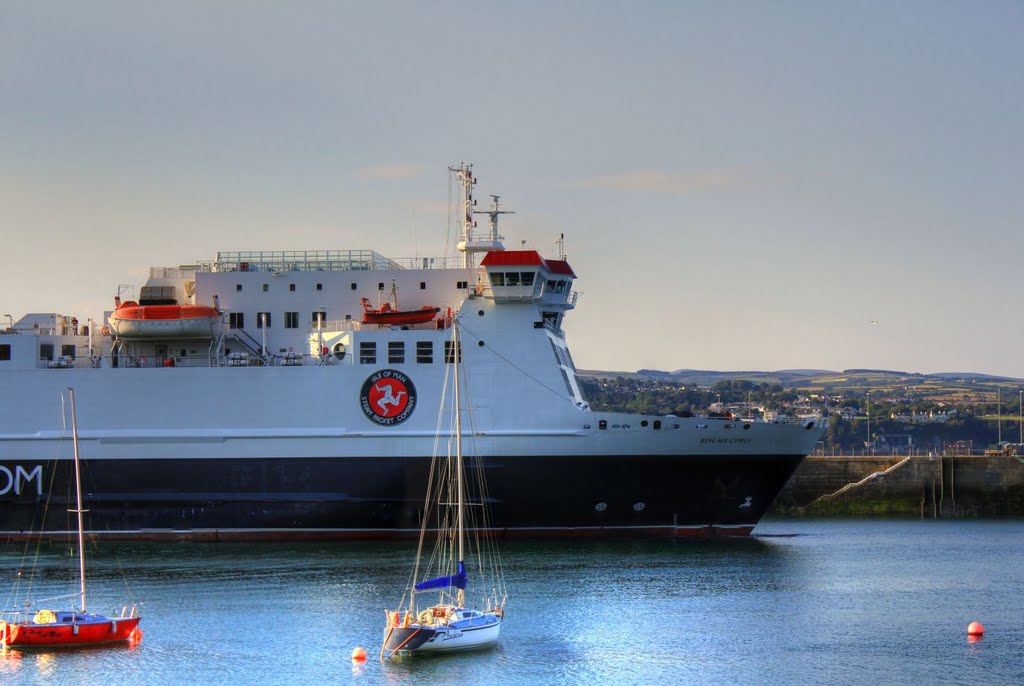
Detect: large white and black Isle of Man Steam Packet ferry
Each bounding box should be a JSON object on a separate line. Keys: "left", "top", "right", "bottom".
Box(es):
{"left": 0, "top": 164, "right": 822, "bottom": 541}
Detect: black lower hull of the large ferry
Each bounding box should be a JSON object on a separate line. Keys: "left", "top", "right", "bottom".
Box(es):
{"left": 0, "top": 455, "right": 803, "bottom": 541}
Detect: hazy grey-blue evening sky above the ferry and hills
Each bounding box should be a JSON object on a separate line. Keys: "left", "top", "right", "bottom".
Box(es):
{"left": 0, "top": 0, "right": 1024, "bottom": 378}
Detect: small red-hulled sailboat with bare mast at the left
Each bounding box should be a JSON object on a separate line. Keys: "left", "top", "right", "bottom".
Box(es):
{"left": 0, "top": 388, "right": 142, "bottom": 649}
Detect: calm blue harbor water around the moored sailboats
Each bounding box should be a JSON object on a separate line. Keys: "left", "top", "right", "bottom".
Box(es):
{"left": 0, "top": 520, "right": 1024, "bottom": 686}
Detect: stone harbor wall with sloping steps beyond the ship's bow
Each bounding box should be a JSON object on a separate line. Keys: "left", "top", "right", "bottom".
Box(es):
{"left": 772, "top": 455, "right": 1024, "bottom": 517}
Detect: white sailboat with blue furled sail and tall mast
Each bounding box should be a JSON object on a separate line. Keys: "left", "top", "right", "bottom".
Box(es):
{"left": 381, "top": 320, "right": 508, "bottom": 658}
